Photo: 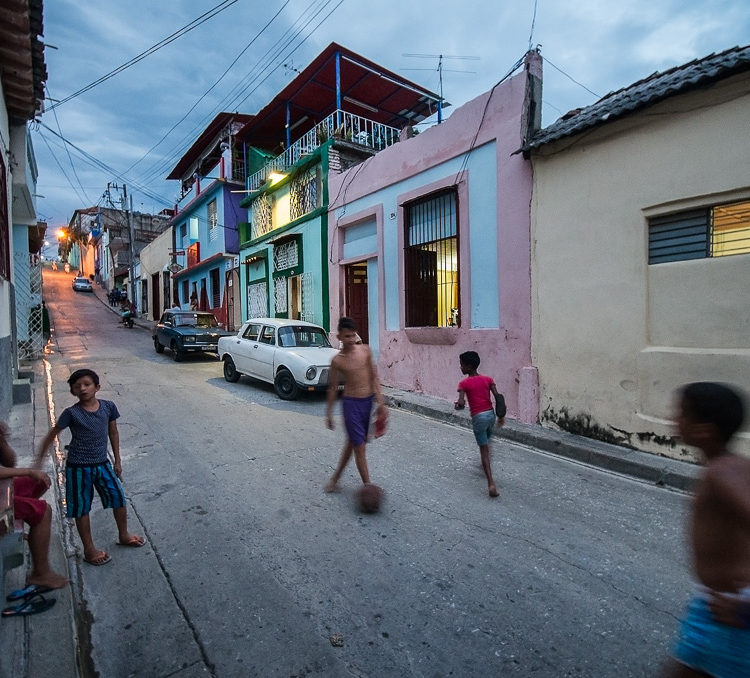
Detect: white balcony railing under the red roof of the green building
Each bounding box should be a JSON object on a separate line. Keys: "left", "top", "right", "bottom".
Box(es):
{"left": 247, "top": 110, "right": 400, "bottom": 191}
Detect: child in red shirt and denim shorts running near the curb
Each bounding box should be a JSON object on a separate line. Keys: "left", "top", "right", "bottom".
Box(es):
{"left": 454, "top": 351, "right": 506, "bottom": 497}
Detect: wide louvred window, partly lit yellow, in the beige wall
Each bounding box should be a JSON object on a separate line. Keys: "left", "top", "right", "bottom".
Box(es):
{"left": 648, "top": 201, "right": 750, "bottom": 264}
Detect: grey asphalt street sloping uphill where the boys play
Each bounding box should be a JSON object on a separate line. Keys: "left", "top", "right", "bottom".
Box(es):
{"left": 44, "top": 272, "right": 691, "bottom": 678}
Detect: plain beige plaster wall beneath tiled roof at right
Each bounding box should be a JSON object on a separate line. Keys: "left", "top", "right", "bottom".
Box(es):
{"left": 532, "top": 76, "right": 750, "bottom": 457}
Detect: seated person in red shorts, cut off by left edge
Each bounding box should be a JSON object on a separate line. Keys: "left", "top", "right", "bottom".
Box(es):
{"left": 0, "top": 422, "right": 70, "bottom": 593}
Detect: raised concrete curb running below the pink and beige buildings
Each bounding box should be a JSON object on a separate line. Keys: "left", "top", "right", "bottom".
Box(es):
{"left": 383, "top": 387, "right": 700, "bottom": 492}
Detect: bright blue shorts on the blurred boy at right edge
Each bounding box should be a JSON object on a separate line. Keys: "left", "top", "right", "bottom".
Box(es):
{"left": 673, "top": 595, "right": 750, "bottom": 678}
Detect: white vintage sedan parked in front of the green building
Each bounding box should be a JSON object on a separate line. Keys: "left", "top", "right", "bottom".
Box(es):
{"left": 219, "top": 318, "right": 338, "bottom": 400}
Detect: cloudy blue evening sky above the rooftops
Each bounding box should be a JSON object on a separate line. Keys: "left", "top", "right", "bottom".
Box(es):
{"left": 31, "top": 0, "right": 750, "bottom": 244}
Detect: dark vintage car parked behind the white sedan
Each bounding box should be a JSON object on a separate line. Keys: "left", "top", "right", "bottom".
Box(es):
{"left": 152, "top": 311, "right": 234, "bottom": 362}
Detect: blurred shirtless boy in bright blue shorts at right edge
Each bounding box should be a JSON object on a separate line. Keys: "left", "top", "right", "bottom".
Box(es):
{"left": 664, "top": 382, "right": 750, "bottom": 678}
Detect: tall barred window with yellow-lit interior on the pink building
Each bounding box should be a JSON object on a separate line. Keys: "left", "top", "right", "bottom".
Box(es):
{"left": 404, "top": 189, "right": 460, "bottom": 327}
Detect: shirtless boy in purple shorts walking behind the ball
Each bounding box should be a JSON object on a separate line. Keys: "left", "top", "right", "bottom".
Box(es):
{"left": 325, "top": 317, "right": 388, "bottom": 492}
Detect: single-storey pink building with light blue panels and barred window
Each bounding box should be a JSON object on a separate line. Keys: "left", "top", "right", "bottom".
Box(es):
{"left": 328, "top": 52, "right": 542, "bottom": 423}
